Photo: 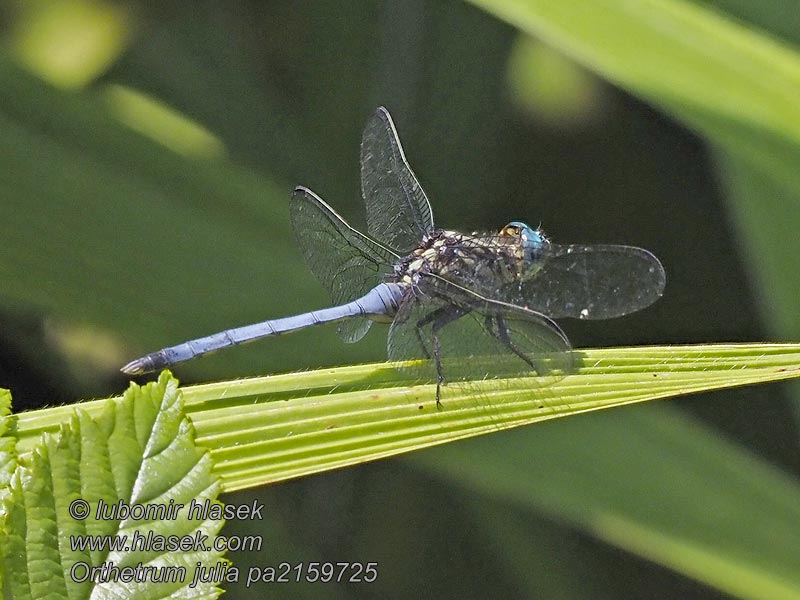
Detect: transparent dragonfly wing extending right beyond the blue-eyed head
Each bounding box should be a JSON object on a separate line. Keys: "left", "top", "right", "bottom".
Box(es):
{"left": 512, "top": 245, "right": 667, "bottom": 319}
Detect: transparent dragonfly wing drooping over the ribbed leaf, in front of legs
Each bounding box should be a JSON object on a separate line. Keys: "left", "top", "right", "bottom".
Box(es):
{"left": 387, "top": 288, "right": 573, "bottom": 382}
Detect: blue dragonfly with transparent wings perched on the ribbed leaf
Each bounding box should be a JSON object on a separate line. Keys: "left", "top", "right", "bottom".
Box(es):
{"left": 121, "top": 107, "right": 666, "bottom": 407}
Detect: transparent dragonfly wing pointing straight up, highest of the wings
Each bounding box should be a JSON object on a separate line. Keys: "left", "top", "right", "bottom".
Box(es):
{"left": 361, "top": 107, "right": 433, "bottom": 254}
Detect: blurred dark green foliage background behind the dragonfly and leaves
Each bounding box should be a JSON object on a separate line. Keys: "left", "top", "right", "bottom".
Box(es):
{"left": 0, "top": 0, "right": 800, "bottom": 598}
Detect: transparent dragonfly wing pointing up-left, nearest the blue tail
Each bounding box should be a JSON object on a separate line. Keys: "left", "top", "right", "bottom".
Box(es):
{"left": 289, "top": 187, "right": 397, "bottom": 342}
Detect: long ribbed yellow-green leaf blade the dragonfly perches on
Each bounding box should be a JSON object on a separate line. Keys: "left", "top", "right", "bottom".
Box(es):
{"left": 10, "top": 344, "right": 800, "bottom": 491}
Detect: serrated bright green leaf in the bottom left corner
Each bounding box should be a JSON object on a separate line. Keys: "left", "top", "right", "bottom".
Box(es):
{"left": 0, "top": 374, "right": 224, "bottom": 598}
